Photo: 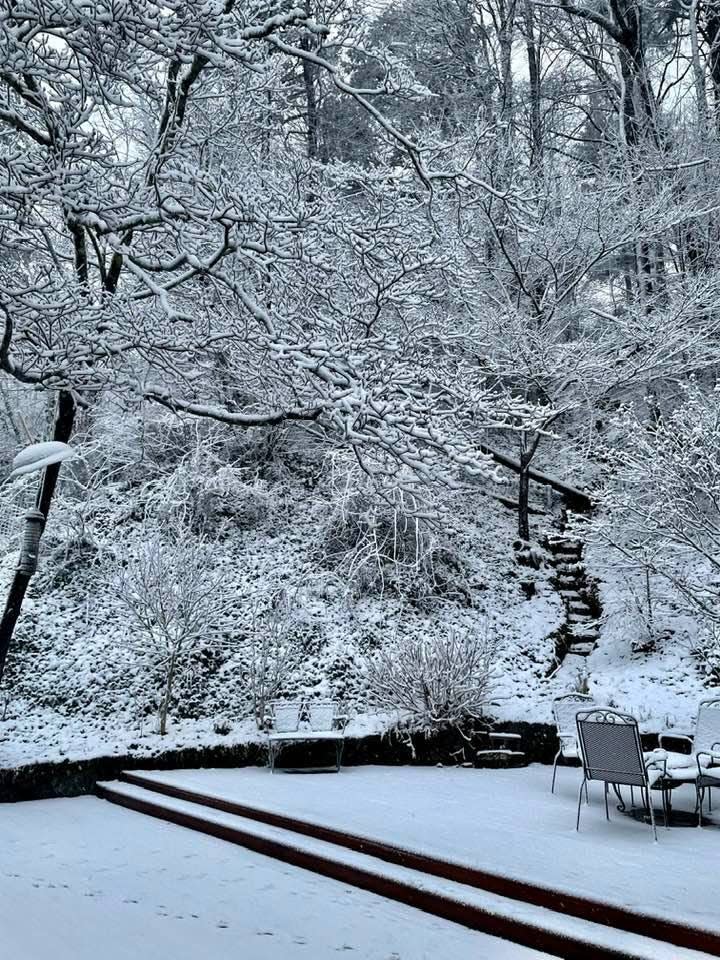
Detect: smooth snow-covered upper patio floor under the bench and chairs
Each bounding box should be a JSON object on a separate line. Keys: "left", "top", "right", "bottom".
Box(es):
{"left": 131, "top": 765, "right": 720, "bottom": 930}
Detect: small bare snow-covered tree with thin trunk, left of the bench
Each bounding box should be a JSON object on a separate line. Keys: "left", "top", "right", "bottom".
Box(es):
{"left": 113, "top": 529, "right": 231, "bottom": 736}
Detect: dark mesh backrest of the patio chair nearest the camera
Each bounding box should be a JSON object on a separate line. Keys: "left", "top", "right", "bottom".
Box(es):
{"left": 577, "top": 707, "right": 647, "bottom": 786}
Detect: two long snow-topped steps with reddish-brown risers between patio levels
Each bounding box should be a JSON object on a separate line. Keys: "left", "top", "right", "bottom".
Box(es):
{"left": 97, "top": 773, "right": 720, "bottom": 960}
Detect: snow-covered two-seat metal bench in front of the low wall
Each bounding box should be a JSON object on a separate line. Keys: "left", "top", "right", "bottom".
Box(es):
{"left": 265, "top": 700, "right": 347, "bottom": 773}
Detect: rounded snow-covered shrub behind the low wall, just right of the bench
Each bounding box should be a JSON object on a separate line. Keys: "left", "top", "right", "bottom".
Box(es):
{"left": 368, "top": 629, "right": 500, "bottom": 729}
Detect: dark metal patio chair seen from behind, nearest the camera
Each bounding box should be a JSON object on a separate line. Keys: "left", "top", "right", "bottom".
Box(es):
{"left": 575, "top": 707, "right": 667, "bottom": 840}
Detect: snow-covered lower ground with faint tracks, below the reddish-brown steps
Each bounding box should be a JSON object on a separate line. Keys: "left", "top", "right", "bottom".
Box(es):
{"left": 0, "top": 792, "right": 544, "bottom": 960}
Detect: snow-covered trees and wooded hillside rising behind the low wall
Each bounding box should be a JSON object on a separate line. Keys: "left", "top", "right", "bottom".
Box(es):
{"left": 0, "top": 0, "right": 720, "bottom": 768}
